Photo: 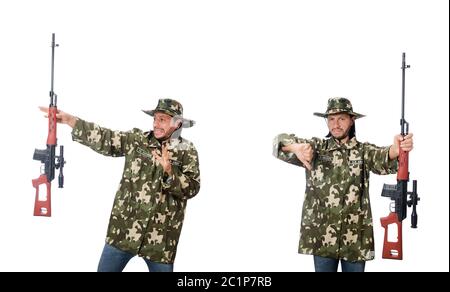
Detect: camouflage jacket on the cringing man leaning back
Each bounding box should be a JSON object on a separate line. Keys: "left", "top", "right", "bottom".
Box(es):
{"left": 72, "top": 120, "right": 200, "bottom": 263}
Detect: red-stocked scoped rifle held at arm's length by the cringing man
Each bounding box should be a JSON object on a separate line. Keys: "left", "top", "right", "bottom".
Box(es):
{"left": 31, "top": 33, "right": 65, "bottom": 217}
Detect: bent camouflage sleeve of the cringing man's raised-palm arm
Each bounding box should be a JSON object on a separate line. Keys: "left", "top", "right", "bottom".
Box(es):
{"left": 162, "top": 144, "right": 200, "bottom": 199}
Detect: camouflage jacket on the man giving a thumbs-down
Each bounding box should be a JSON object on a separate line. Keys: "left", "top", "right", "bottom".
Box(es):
{"left": 274, "top": 134, "right": 397, "bottom": 261}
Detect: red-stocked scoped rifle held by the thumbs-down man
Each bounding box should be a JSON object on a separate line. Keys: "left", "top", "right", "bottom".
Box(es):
{"left": 381, "top": 53, "right": 420, "bottom": 260}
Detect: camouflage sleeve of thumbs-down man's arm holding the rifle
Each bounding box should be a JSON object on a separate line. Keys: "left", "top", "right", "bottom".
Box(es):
{"left": 364, "top": 143, "right": 398, "bottom": 175}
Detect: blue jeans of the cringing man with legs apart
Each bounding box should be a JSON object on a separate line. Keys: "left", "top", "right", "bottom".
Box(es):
{"left": 97, "top": 244, "right": 173, "bottom": 272}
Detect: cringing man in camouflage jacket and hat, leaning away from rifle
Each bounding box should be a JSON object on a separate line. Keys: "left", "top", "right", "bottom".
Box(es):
{"left": 42, "top": 99, "right": 200, "bottom": 271}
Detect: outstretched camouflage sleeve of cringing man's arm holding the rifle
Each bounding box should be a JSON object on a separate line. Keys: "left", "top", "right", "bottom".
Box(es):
{"left": 72, "top": 119, "right": 133, "bottom": 157}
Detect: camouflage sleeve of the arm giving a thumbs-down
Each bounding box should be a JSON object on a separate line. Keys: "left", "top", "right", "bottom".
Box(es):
{"left": 272, "top": 133, "right": 317, "bottom": 167}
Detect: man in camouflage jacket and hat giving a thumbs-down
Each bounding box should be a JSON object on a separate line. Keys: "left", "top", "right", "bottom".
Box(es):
{"left": 274, "top": 98, "right": 412, "bottom": 271}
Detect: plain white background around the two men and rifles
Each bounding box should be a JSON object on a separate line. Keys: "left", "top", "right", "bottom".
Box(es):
{"left": 0, "top": 0, "right": 449, "bottom": 271}
